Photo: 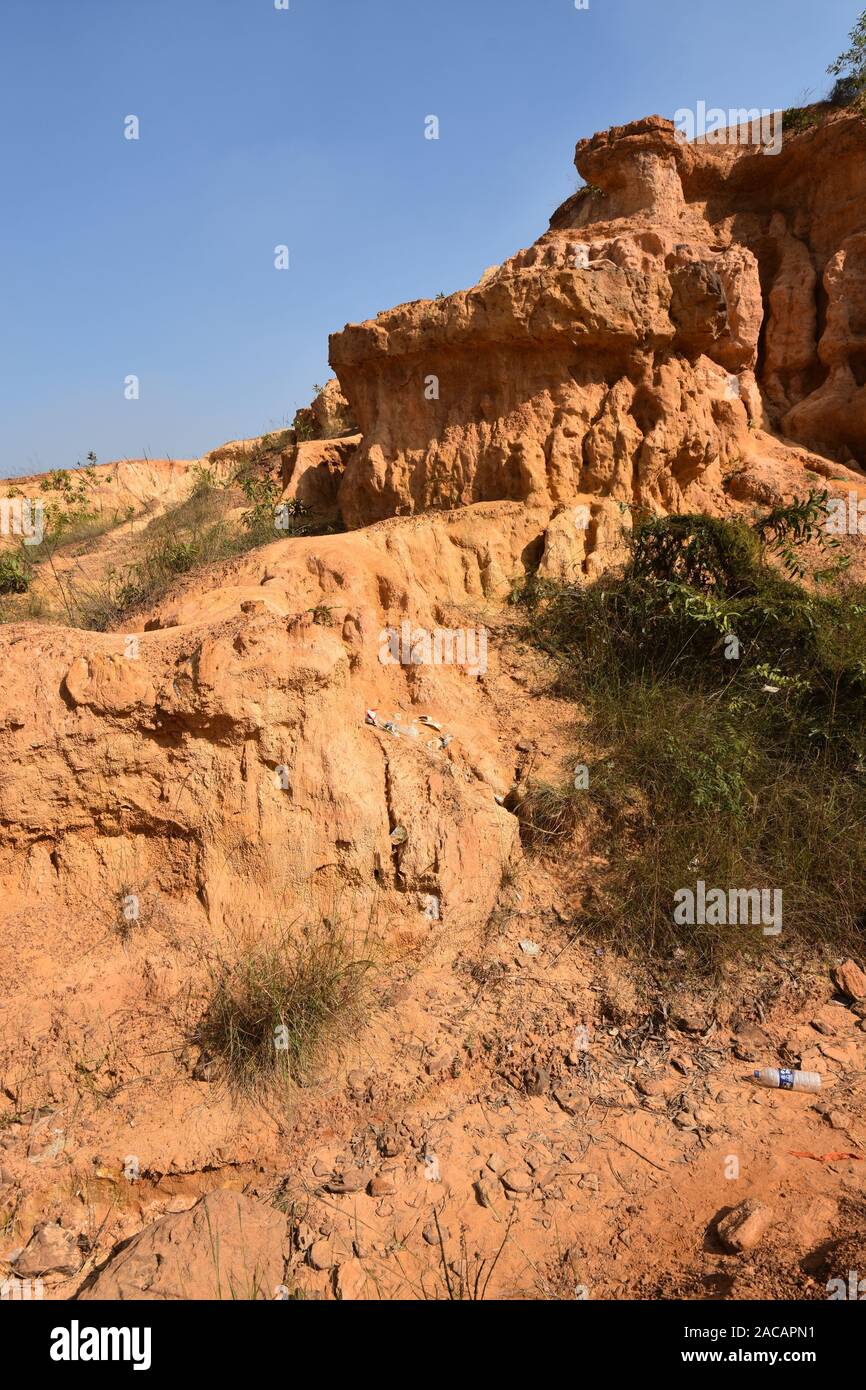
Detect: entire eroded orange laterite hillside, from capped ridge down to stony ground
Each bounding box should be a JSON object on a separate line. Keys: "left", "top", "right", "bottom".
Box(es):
{"left": 0, "top": 113, "right": 866, "bottom": 1298}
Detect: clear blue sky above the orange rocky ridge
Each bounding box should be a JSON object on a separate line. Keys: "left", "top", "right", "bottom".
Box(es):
{"left": 0, "top": 0, "right": 866, "bottom": 475}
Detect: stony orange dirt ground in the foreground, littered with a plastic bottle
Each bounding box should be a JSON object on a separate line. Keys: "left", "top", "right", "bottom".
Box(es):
{"left": 0, "top": 614, "right": 866, "bottom": 1300}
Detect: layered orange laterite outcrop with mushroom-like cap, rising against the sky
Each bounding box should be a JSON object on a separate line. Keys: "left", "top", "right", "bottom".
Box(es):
{"left": 331, "top": 114, "right": 866, "bottom": 553}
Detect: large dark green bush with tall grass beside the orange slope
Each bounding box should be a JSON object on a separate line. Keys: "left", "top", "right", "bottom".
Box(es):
{"left": 516, "top": 499, "right": 866, "bottom": 967}
